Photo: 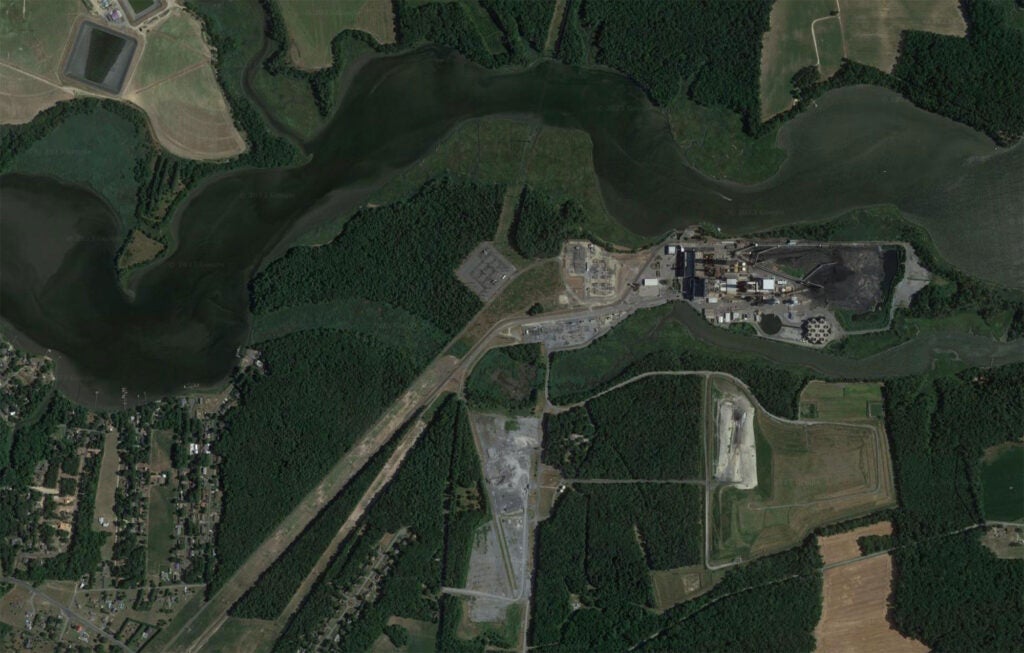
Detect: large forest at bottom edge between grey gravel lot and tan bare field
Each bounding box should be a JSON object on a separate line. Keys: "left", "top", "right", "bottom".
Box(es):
{"left": 529, "top": 486, "right": 821, "bottom": 652}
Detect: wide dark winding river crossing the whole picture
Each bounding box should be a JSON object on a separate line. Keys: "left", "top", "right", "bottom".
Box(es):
{"left": 0, "top": 49, "right": 1024, "bottom": 405}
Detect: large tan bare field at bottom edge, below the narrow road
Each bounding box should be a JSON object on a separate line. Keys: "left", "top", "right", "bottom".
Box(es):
{"left": 814, "top": 555, "right": 928, "bottom": 653}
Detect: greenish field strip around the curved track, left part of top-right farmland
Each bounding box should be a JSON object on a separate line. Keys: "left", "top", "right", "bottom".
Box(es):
{"left": 761, "top": 0, "right": 842, "bottom": 120}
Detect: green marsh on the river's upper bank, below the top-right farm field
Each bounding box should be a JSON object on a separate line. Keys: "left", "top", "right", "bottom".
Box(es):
{"left": 666, "top": 94, "right": 785, "bottom": 183}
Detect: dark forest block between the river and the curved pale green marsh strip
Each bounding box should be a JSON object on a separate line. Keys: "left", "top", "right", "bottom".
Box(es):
{"left": 250, "top": 178, "right": 502, "bottom": 336}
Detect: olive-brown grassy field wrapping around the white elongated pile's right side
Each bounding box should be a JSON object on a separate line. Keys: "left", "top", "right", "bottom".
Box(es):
{"left": 709, "top": 379, "right": 895, "bottom": 563}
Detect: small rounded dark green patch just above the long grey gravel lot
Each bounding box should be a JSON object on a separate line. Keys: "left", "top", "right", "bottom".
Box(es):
{"left": 465, "top": 344, "right": 547, "bottom": 413}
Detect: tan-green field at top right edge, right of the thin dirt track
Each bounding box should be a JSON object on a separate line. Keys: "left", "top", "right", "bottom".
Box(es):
{"left": 837, "top": 0, "right": 967, "bottom": 73}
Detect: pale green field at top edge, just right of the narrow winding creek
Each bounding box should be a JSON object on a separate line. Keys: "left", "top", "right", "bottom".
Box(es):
{"left": 278, "top": 0, "right": 394, "bottom": 71}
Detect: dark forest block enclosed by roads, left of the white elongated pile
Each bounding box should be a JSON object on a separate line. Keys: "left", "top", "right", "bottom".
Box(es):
{"left": 542, "top": 376, "right": 703, "bottom": 480}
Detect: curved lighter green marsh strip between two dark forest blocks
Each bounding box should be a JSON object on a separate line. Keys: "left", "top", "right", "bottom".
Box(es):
{"left": 249, "top": 298, "right": 447, "bottom": 363}
